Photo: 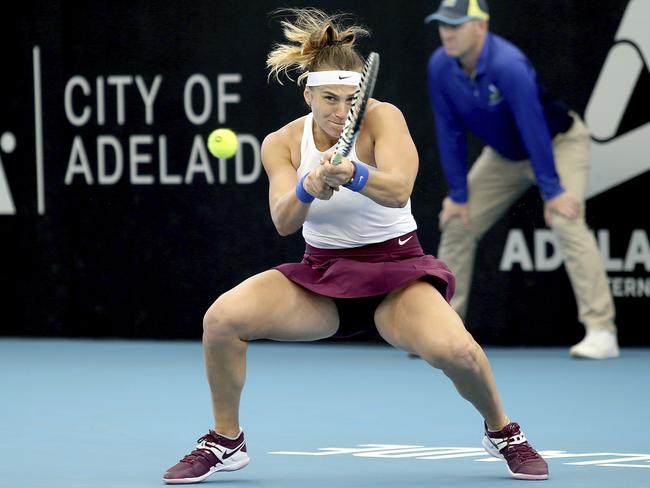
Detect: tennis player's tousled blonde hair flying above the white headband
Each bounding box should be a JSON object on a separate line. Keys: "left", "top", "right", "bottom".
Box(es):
{"left": 266, "top": 8, "right": 370, "bottom": 84}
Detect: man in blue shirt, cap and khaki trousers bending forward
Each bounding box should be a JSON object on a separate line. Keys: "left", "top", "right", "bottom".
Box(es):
{"left": 426, "top": 0, "right": 619, "bottom": 359}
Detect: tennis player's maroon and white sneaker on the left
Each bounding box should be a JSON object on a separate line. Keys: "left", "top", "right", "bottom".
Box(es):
{"left": 163, "top": 430, "right": 250, "bottom": 484}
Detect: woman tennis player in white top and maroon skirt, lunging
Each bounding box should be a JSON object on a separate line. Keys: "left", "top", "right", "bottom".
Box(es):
{"left": 163, "top": 9, "right": 548, "bottom": 483}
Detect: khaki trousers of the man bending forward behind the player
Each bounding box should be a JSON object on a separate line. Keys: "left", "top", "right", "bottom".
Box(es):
{"left": 438, "top": 113, "right": 616, "bottom": 332}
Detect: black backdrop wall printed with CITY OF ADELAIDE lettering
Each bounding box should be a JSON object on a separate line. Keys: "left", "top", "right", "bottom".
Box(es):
{"left": 0, "top": 0, "right": 650, "bottom": 344}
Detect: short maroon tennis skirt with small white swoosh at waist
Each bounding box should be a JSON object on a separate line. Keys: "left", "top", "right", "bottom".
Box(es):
{"left": 275, "top": 231, "right": 454, "bottom": 301}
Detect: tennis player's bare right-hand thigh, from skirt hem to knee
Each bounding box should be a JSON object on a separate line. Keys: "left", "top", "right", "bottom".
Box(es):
{"left": 375, "top": 281, "right": 473, "bottom": 361}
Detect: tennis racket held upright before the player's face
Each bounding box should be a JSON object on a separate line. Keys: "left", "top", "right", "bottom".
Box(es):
{"left": 330, "top": 52, "right": 379, "bottom": 164}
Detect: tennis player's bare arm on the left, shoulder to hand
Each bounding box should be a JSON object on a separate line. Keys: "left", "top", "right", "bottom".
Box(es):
{"left": 262, "top": 128, "right": 332, "bottom": 236}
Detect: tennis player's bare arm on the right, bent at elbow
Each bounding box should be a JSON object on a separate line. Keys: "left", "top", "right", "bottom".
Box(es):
{"left": 318, "top": 102, "right": 418, "bottom": 207}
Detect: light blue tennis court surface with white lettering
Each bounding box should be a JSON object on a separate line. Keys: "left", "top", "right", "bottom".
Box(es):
{"left": 0, "top": 338, "right": 650, "bottom": 488}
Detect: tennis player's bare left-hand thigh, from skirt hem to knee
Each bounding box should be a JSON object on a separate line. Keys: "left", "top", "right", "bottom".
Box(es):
{"left": 205, "top": 270, "right": 339, "bottom": 341}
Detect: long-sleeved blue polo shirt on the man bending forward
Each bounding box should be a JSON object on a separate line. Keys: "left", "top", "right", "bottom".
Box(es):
{"left": 428, "top": 33, "right": 572, "bottom": 203}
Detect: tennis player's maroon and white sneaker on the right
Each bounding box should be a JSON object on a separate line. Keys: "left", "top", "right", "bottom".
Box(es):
{"left": 483, "top": 422, "right": 548, "bottom": 480}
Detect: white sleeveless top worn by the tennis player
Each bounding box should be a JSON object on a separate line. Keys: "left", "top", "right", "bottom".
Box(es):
{"left": 297, "top": 113, "right": 417, "bottom": 249}
